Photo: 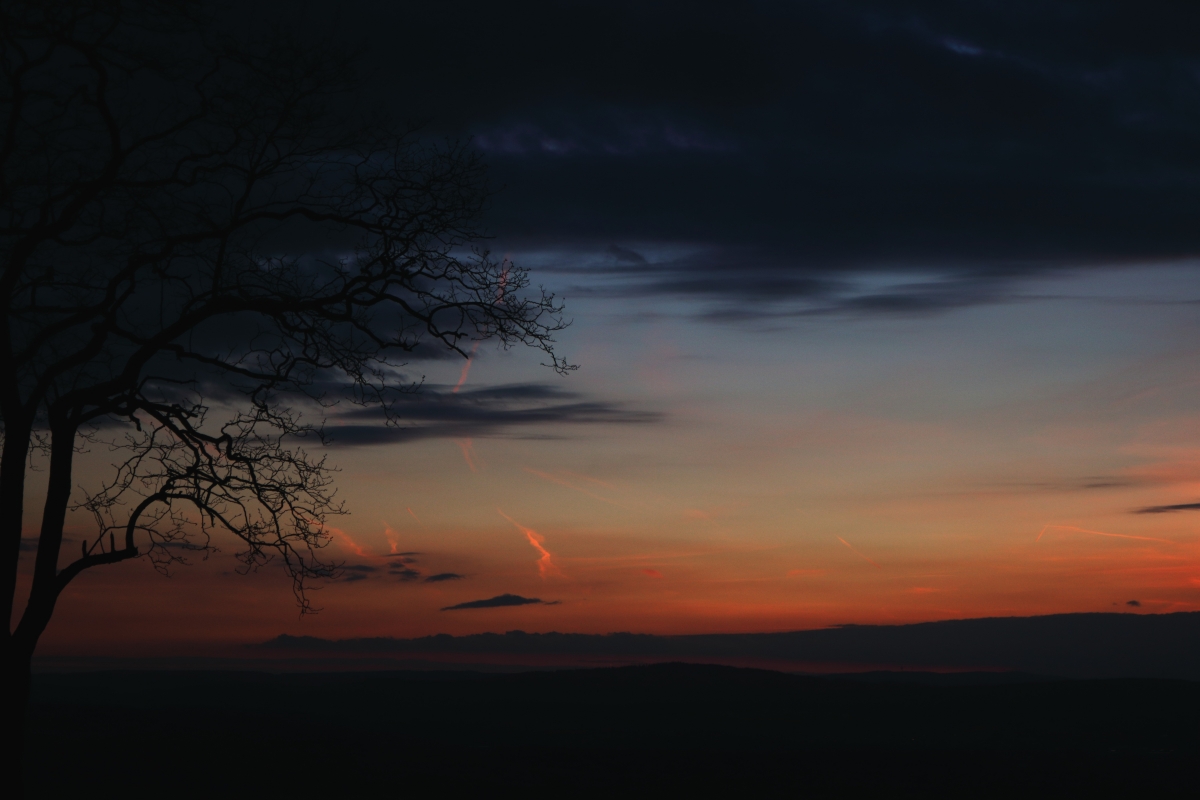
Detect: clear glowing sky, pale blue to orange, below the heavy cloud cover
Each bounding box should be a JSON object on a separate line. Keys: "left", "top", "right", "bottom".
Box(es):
{"left": 16, "top": 263, "right": 1200, "bottom": 654}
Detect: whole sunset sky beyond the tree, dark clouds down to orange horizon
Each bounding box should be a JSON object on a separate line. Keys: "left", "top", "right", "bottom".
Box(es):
{"left": 21, "top": 0, "right": 1200, "bottom": 652}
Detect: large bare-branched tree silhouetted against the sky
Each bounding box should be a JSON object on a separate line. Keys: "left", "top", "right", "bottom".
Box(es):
{"left": 0, "top": 0, "right": 571, "bottom": 766}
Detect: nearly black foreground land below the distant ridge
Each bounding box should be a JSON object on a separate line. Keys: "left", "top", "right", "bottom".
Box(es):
{"left": 26, "top": 664, "right": 1200, "bottom": 798}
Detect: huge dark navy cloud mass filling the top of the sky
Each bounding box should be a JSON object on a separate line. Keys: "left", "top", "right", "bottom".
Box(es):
{"left": 276, "top": 0, "right": 1200, "bottom": 319}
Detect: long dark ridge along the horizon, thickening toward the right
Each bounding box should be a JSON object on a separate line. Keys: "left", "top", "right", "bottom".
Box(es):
{"left": 254, "top": 612, "right": 1200, "bottom": 680}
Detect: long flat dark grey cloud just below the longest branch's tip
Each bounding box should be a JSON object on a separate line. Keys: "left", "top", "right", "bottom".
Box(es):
{"left": 325, "top": 384, "right": 662, "bottom": 446}
